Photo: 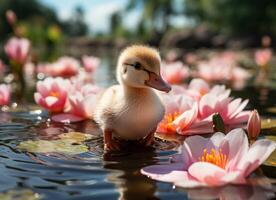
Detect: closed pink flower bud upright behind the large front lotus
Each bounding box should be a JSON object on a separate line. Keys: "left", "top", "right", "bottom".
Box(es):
{"left": 247, "top": 110, "right": 261, "bottom": 140}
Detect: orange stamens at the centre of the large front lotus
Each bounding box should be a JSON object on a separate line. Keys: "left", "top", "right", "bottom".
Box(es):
{"left": 199, "top": 148, "right": 228, "bottom": 169}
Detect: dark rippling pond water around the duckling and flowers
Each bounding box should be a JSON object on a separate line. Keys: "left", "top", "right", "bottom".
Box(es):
{"left": 0, "top": 55, "right": 276, "bottom": 200}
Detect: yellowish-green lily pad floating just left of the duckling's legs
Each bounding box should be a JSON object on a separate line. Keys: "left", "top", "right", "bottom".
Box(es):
{"left": 17, "top": 132, "right": 92, "bottom": 155}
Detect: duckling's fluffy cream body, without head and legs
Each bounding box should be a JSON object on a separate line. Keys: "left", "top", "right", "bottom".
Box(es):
{"left": 96, "top": 85, "right": 165, "bottom": 140}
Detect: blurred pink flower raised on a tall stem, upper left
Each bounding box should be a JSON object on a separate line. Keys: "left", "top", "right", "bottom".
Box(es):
{"left": 4, "top": 37, "right": 30, "bottom": 64}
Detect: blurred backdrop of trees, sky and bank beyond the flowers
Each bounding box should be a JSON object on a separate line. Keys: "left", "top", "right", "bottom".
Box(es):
{"left": 0, "top": 0, "right": 276, "bottom": 59}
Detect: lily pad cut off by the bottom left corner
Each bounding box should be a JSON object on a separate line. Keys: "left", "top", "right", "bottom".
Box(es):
{"left": 0, "top": 189, "right": 41, "bottom": 200}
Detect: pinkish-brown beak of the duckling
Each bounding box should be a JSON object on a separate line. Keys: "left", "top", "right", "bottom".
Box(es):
{"left": 145, "top": 72, "right": 172, "bottom": 93}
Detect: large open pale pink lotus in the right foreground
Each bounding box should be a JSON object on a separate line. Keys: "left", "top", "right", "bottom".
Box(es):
{"left": 141, "top": 129, "right": 276, "bottom": 188}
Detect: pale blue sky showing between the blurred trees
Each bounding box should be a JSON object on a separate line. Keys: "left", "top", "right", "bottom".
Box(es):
{"left": 39, "top": 0, "right": 140, "bottom": 32}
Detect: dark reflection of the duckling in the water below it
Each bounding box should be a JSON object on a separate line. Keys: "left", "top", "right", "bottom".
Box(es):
{"left": 103, "top": 149, "right": 156, "bottom": 200}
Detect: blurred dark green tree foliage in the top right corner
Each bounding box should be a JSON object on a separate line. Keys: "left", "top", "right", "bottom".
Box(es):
{"left": 185, "top": 0, "right": 276, "bottom": 35}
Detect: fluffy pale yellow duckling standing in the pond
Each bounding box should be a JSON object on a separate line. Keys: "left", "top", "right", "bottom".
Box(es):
{"left": 94, "top": 45, "right": 171, "bottom": 150}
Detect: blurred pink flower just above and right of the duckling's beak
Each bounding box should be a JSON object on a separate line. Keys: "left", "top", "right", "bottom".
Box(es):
{"left": 162, "top": 62, "right": 190, "bottom": 84}
